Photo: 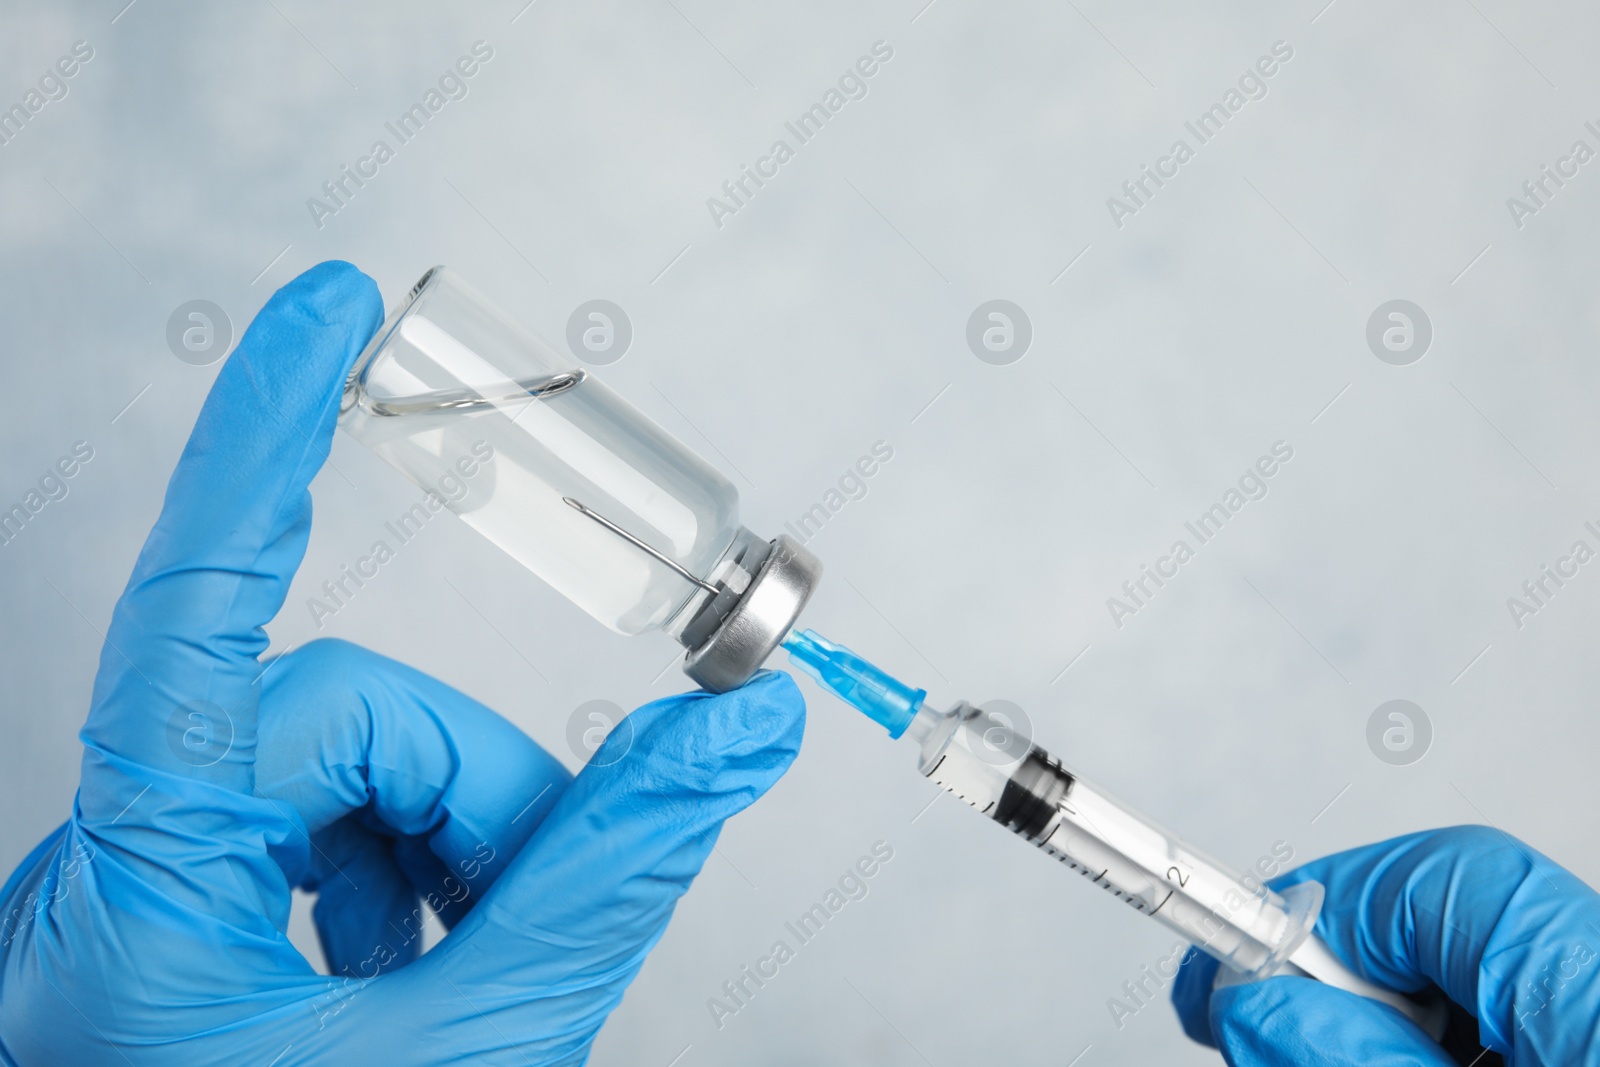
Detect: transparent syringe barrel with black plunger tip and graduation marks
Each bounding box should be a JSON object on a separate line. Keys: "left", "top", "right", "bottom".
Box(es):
{"left": 922, "top": 704, "right": 1320, "bottom": 979}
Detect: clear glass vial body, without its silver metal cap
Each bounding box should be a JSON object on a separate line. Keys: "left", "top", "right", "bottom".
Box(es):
{"left": 339, "top": 267, "right": 748, "bottom": 648}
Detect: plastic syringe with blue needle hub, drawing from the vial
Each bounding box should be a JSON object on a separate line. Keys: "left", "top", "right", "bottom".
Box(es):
{"left": 782, "top": 630, "right": 1448, "bottom": 1040}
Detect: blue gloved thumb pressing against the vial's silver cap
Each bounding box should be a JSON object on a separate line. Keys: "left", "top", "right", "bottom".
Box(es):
{"left": 392, "top": 672, "right": 805, "bottom": 1056}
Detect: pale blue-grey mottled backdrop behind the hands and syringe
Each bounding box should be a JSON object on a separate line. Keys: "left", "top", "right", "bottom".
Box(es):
{"left": 0, "top": 0, "right": 1600, "bottom": 1067}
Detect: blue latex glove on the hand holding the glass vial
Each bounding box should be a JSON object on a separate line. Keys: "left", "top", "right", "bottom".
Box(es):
{"left": 0, "top": 262, "right": 805, "bottom": 1067}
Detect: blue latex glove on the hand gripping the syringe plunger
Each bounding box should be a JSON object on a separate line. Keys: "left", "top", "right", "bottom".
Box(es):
{"left": 1173, "top": 827, "right": 1600, "bottom": 1067}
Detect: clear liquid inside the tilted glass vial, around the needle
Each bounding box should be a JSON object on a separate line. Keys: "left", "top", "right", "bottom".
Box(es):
{"left": 341, "top": 376, "right": 739, "bottom": 635}
